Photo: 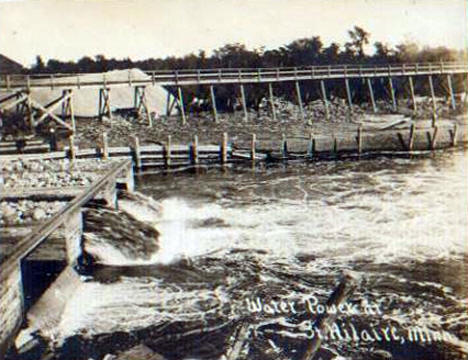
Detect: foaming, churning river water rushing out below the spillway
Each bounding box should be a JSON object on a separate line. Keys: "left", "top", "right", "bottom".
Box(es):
{"left": 16, "top": 150, "right": 468, "bottom": 359}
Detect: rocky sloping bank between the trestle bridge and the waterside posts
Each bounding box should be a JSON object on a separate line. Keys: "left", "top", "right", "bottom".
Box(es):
{"left": 75, "top": 98, "right": 464, "bottom": 148}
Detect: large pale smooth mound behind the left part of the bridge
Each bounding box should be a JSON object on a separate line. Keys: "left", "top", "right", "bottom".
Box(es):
{"left": 0, "top": 69, "right": 177, "bottom": 117}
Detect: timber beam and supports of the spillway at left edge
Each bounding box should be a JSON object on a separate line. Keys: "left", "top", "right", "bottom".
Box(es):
{"left": 0, "top": 159, "right": 133, "bottom": 358}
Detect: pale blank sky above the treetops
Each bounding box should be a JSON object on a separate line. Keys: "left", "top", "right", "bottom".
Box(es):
{"left": 0, "top": 0, "right": 468, "bottom": 66}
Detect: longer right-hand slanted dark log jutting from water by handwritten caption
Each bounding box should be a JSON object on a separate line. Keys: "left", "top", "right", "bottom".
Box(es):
{"left": 301, "top": 272, "right": 359, "bottom": 360}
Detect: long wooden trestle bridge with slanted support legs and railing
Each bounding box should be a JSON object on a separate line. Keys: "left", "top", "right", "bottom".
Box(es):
{"left": 0, "top": 62, "right": 468, "bottom": 133}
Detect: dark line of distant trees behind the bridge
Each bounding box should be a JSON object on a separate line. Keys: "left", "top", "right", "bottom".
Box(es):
{"left": 30, "top": 26, "right": 463, "bottom": 73}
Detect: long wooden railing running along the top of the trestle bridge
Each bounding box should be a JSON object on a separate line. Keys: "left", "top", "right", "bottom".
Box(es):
{"left": 0, "top": 62, "right": 468, "bottom": 90}
